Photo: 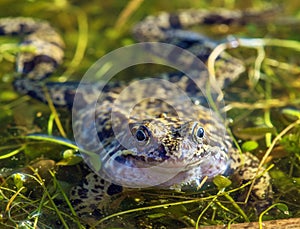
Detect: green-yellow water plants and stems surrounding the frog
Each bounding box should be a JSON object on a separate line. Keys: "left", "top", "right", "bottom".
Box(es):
{"left": 0, "top": 0, "right": 300, "bottom": 228}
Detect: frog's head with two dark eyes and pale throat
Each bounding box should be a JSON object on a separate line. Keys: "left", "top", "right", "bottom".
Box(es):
{"left": 102, "top": 115, "right": 229, "bottom": 187}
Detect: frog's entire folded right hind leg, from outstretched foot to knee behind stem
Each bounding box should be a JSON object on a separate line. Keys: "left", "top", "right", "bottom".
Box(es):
{"left": 133, "top": 8, "right": 278, "bottom": 87}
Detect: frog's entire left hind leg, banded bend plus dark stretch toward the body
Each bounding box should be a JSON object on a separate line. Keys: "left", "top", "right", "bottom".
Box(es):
{"left": 0, "top": 17, "right": 77, "bottom": 106}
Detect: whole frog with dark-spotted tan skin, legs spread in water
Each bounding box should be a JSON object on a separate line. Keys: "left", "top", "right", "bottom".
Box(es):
{"left": 0, "top": 10, "right": 271, "bottom": 224}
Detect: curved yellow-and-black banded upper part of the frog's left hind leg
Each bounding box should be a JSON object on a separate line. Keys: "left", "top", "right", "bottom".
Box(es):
{"left": 0, "top": 17, "right": 65, "bottom": 80}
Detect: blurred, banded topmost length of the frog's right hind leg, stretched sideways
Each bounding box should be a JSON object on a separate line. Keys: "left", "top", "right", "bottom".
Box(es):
{"left": 133, "top": 8, "right": 278, "bottom": 41}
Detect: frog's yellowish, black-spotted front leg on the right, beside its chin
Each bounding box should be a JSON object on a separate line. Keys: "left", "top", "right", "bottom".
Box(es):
{"left": 230, "top": 151, "right": 272, "bottom": 213}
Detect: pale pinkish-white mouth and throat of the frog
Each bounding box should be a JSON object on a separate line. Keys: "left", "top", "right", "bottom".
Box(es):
{"left": 98, "top": 144, "right": 228, "bottom": 188}
